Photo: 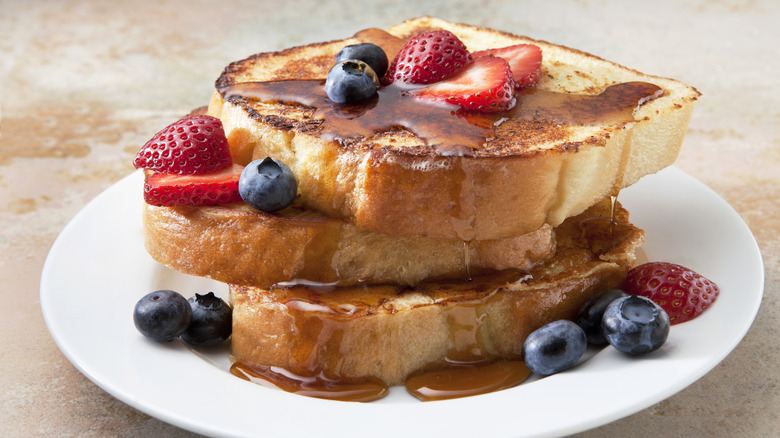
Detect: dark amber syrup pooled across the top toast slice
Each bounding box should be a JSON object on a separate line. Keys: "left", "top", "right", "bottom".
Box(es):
{"left": 219, "top": 79, "right": 663, "bottom": 157}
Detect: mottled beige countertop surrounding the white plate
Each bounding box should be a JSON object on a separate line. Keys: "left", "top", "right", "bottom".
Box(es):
{"left": 0, "top": 0, "right": 780, "bottom": 437}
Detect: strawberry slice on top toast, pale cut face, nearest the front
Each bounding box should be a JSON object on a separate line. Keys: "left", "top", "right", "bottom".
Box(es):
{"left": 410, "top": 56, "right": 516, "bottom": 112}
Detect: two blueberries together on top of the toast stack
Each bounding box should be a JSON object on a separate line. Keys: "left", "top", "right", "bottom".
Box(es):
{"left": 325, "top": 43, "right": 388, "bottom": 103}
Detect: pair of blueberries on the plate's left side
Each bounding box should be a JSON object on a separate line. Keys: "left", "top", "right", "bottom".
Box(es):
{"left": 133, "top": 290, "right": 233, "bottom": 346}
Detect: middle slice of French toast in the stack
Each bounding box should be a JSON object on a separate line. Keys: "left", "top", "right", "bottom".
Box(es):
{"left": 143, "top": 204, "right": 555, "bottom": 288}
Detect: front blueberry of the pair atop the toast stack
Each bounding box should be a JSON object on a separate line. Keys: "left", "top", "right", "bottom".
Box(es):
{"left": 325, "top": 59, "right": 379, "bottom": 103}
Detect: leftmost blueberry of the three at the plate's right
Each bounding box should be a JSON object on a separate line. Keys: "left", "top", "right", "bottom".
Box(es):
{"left": 523, "top": 320, "right": 588, "bottom": 376}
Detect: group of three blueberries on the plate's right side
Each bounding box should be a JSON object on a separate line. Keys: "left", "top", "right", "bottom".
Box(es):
{"left": 523, "top": 289, "right": 670, "bottom": 376}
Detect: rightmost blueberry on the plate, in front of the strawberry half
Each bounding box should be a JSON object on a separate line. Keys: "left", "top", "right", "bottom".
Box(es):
{"left": 601, "top": 295, "right": 669, "bottom": 355}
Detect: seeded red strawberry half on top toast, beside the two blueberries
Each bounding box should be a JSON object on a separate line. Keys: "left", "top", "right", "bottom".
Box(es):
{"left": 383, "top": 30, "right": 471, "bottom": 85}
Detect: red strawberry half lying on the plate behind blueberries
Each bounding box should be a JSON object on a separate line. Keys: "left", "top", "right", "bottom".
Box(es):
{"left": 623, "top": 262, "right": 720, "bottom": 325}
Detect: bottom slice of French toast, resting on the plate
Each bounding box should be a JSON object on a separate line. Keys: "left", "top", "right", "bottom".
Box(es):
{"left": 230, "top": 203, "right": 644, "bottom": 385}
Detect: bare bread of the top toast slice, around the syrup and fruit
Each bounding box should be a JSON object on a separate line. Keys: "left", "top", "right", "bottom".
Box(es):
{"left": 209, "top": 17, "right": 699, "bottom": 240}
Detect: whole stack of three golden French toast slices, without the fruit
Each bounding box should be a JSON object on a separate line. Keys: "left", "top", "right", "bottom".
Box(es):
{"left": 144, "top": 17, "right": 699, "bottom": 396}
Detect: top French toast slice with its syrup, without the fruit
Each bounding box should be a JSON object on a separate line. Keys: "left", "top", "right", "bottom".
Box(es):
{"left": 209, "top": 17, "right": 699, "bottom": 240}
